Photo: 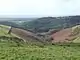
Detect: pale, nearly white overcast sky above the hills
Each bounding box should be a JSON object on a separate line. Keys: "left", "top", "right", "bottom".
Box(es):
{"left": 0, "top": 0, "right": 80, "bottom": 17}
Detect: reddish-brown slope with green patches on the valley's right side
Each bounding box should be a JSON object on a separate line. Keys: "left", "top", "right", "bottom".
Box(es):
{"left": 51, "top": 25, "right": 80, "bottom": 43}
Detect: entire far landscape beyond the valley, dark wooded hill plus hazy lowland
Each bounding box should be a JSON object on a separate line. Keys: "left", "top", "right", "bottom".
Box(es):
{"left": 0, "top": 16, "right": 80, "bottom": 33}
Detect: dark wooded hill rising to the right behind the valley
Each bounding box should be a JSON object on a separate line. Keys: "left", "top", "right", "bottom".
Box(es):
{"left": 22, "top": 16, "right": 80, "bottom": 32}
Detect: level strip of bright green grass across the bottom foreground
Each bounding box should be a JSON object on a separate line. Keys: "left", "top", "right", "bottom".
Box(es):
{"left": 0, "top": 45, "right": 80, "bottom": 60}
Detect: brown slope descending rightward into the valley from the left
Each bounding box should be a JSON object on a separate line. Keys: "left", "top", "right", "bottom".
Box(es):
{"left": 12, "top": 28, "right": 45, "bottom": 43}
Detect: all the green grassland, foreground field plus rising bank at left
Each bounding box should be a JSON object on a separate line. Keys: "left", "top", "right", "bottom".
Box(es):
{"left": 0, "top": 26, "right": 80, "bottom": 60}
